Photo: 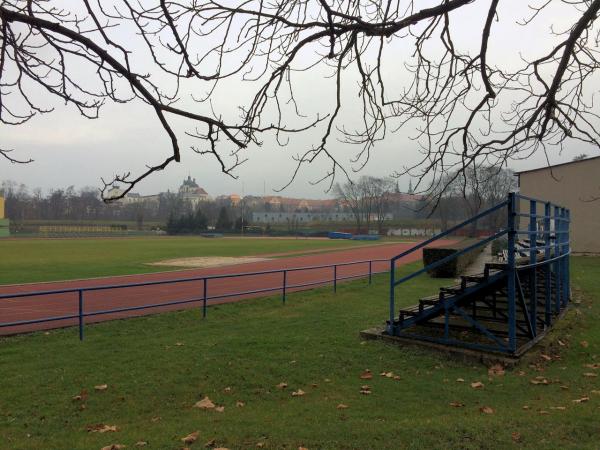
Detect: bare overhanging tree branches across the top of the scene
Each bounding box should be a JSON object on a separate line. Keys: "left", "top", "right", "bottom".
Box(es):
{"left": 0, "top": 0, "right": 600, "bottom": 200}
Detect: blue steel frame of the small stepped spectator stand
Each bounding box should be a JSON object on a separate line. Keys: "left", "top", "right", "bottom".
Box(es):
{"left": 386, "top": 193, "right": 570, "bottom": 354}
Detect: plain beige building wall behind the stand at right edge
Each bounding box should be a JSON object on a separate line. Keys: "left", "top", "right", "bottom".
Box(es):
{"left": 517, "top": 156, "right": 600, "bottom": 253}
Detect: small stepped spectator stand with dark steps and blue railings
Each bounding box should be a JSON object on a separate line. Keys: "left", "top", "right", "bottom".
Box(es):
{"left": 386, "top": 194, "right": 570, "bottom": 355}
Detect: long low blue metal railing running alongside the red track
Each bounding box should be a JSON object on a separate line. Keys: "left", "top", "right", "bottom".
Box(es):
{"left": 0, "top": 255, "right": 389, "bottom": 340}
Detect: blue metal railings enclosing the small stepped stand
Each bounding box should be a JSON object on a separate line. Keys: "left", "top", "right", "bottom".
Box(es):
{"left": 387, "top": 193, "right": 570, "bottom": 353}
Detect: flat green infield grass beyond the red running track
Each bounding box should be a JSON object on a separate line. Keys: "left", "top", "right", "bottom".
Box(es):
{"left": 0, "top": 236, "right": 376, "bottom": 284}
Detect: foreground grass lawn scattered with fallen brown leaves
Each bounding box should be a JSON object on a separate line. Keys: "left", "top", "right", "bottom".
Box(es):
{"left": 0, "top": 258, "right": 600, "bottom": 450}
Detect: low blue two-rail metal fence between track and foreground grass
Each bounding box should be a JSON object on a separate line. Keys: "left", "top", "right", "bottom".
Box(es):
{"left": 0, "top": 259, "right": 389, "bottom": 340}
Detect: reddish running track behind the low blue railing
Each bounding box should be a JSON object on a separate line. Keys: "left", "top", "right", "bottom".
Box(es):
{"left": 0, "top": 240, "right": 452, "bottom": 335}
